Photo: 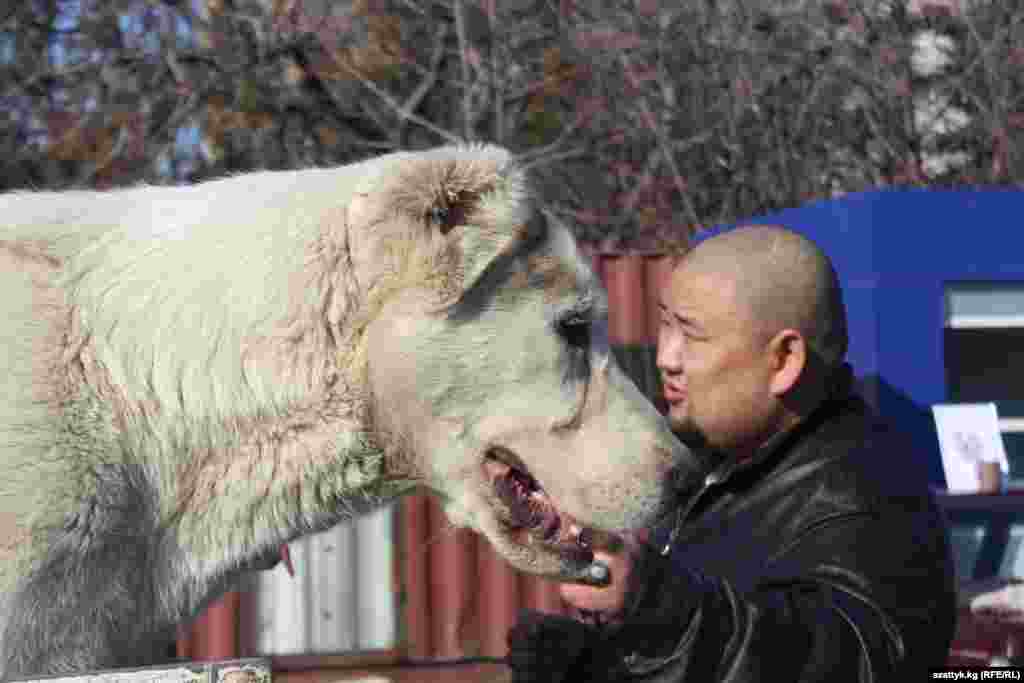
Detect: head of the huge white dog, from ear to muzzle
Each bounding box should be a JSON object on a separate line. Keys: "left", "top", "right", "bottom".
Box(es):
{"left": 348, "top": 146, "right": 694, "bottom": 580}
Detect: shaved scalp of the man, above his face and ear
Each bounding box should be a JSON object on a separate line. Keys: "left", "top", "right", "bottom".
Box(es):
{"left": 678, "top": 225, "right": 848, "bottom": 368}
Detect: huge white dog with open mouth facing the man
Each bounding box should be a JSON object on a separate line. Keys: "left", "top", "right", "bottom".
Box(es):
{"left": 0, "top": 146, "right": 695, "bottom": 678}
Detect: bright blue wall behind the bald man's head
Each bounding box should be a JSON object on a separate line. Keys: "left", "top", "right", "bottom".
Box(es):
{"left": 715, "top": 189, "right": 1024, "bottom": 484}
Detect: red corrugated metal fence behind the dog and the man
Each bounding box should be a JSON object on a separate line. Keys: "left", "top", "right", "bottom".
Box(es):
{"left": 177, "top": 252, "right": 670, "bottom": 659}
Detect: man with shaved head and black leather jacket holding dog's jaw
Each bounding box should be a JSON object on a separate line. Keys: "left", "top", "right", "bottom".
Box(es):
{"left": 509, "top": 226, "right": 956, "bottom": 683}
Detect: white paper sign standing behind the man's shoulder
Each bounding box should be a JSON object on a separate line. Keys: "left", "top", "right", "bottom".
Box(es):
{"left": 932, "top": 403, "right": 1010, "bottom": 494}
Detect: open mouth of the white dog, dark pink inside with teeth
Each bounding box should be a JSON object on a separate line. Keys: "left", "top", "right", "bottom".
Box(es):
{"left": 483, "top": 449, "right": 594, "bottom": 562}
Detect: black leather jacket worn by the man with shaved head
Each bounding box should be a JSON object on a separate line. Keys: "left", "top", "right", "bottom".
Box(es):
{"left": 603, "top": 376, "right": 956, "bottom": 683}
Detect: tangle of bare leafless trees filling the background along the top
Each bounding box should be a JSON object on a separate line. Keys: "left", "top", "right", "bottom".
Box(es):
{"left": 0, "top": 0, "right": 1024, "bottom": 250}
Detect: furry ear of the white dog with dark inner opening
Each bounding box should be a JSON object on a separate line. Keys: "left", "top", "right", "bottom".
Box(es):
{"left": 356, "top": 150, "right": 548, "bottom": 306}
